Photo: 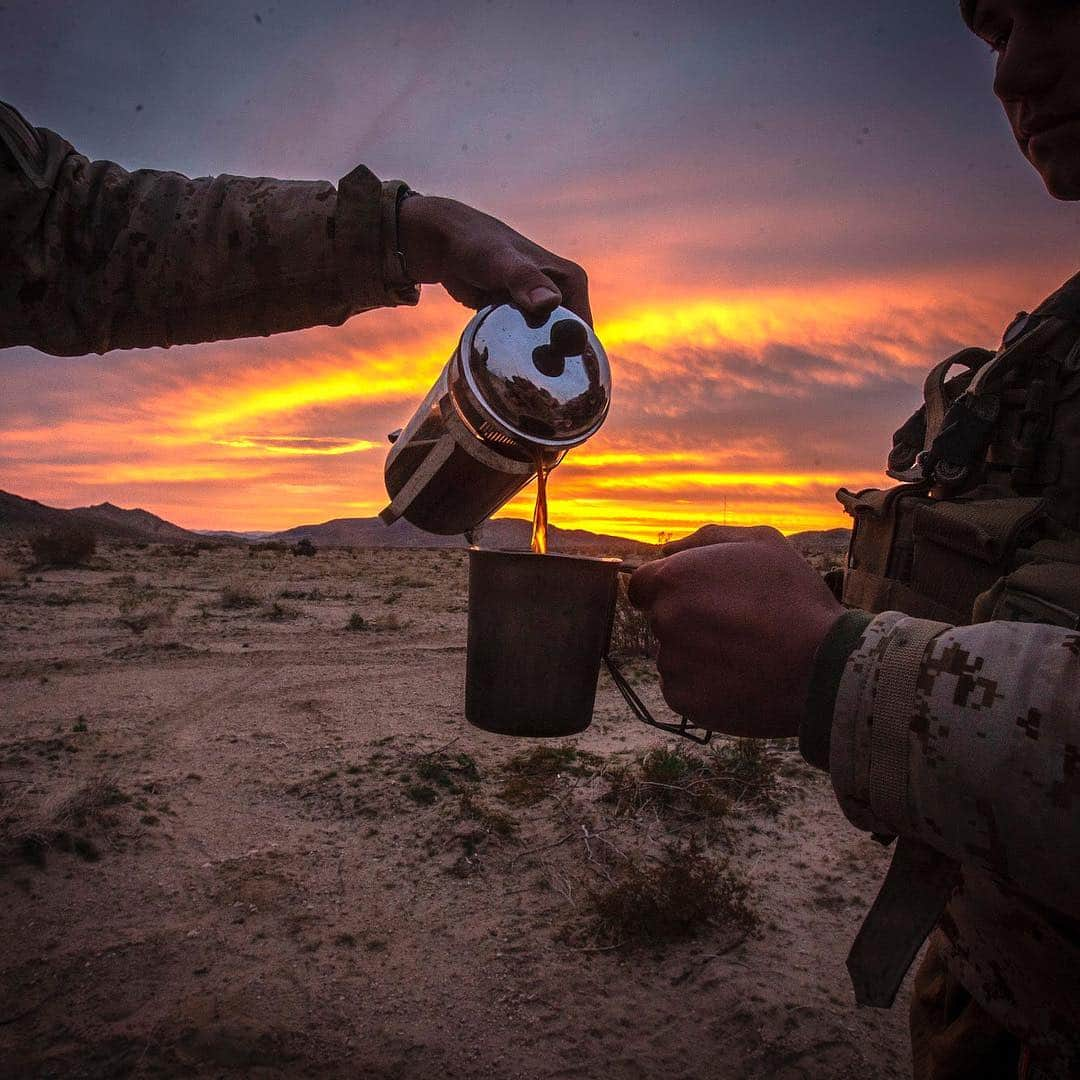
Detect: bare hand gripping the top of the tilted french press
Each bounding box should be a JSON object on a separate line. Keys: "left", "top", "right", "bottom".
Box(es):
{"left": 399, "top": 195, "right": 593, "bottom": 324}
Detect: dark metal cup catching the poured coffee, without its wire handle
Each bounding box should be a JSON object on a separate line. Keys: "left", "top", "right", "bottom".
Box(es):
{"left": 465, "top": 549, "right": 620, "bottom": 738}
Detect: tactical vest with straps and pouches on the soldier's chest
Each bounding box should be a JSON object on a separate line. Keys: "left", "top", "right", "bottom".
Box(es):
{"left": 837, "top": 274, "right": 1080, "bottom": 629}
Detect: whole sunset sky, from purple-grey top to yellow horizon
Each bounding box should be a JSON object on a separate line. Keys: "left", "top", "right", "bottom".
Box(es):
{"left": 0, "top": 0, "right": 1080, "bottom": 540}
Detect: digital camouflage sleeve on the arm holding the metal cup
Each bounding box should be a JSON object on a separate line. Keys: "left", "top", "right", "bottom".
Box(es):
{"left": 829, "top": 611, "right": 1080, "bottom": 917}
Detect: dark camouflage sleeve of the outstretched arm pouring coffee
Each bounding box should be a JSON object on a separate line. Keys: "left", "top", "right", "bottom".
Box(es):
{"left": 0, "top": 103, "right": 419, "bottom": 355}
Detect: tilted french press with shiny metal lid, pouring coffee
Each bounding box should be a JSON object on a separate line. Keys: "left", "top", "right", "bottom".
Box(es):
{"left": 379, "top": 303, "right": 611, "bottom": 536}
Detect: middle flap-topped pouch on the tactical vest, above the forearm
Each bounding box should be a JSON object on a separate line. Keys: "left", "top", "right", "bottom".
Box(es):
{"left": 904, "top": 498, "right": 1045, "bottom": 623}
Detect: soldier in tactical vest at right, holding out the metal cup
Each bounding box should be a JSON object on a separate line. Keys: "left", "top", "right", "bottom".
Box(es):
{"left": 631, "top": 0, "right": 1080, "bottom": 1080}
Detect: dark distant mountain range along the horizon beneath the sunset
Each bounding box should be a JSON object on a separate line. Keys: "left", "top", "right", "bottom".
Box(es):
{"left": 0, "top": 491, "right": 850, "bottom": 557}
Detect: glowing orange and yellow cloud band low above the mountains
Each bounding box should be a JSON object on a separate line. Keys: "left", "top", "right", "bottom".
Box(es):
{"left": 0, "top": 265, "right": 1036, "bottom": 539}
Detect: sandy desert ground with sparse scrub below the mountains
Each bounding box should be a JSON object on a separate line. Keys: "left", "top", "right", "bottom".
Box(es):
{"left": 0, "top": 544, "right": 909, "bottom": 1080}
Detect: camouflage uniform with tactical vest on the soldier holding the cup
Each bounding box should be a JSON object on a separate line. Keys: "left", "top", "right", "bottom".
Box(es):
{"left": 804, "top": 275, "right": 1080, "bottom": 1078}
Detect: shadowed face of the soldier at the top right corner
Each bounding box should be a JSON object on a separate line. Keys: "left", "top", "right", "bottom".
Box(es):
{"left": 972, "top": 0, "right": 1080, "bottom": 199}
